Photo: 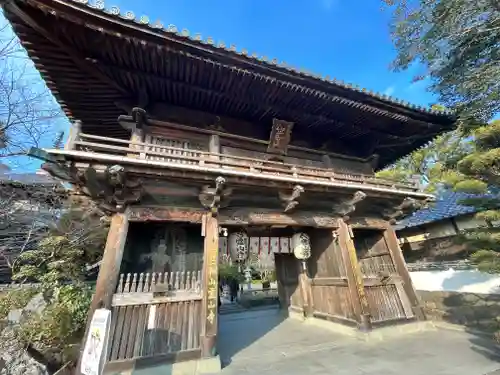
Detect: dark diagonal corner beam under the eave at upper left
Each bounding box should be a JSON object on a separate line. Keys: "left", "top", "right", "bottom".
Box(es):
{"left": 3, "top": 1, "right": 127, "bottom": 95}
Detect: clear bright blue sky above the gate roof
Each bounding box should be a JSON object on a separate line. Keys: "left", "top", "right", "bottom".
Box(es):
{"left": 1, "top": 0, "right": 434, "bottom": 169}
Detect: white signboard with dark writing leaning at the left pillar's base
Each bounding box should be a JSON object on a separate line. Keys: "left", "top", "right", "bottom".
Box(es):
{"left": 80, "top": 309, "right": 111, "bottom": 375}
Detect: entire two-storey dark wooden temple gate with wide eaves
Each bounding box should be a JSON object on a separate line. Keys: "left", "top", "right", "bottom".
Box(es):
{"left": 1, "top": 0, "right": 455, "bottom": 372}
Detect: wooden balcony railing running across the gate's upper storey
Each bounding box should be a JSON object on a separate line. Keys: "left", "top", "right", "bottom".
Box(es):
{"left": 66, "top": 133, "right": 418, "bottom": 191}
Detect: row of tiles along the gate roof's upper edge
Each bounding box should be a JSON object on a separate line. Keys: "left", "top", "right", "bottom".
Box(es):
{"left": 45, "top": 0, "right": 452, "bottom": 115}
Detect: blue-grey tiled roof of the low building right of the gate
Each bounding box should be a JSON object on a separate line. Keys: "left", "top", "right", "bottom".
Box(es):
{"left": 394, "top": 191, "right": 486, "bottom": 230}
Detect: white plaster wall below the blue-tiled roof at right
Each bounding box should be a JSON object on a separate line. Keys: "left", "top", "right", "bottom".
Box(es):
{"left": 410, "top": 269, "right": 500, "bottom": 294}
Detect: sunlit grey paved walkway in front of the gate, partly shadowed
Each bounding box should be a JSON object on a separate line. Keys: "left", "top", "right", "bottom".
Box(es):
{"left": 219, "top": 310, "right": 500, "bottom": 375}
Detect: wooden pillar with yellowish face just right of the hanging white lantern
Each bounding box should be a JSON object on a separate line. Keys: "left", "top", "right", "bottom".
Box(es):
{"left": 338, "top": 219, "right": 371, "bottom": 331}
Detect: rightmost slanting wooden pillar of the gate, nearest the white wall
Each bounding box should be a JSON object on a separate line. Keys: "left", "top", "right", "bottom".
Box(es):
{"left": 384, "top": 226, "right": 426, "bottom": 320}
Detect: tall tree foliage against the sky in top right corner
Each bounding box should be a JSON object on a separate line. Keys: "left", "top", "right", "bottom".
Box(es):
{"left": 383, "top": 0, "right": 500, "bottom": 126}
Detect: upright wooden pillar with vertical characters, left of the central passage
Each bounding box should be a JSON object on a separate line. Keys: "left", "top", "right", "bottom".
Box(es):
{"left": 201, "top": 213, "right": 219, "bottom": 358}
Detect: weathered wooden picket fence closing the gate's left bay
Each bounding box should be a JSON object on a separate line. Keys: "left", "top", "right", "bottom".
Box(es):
{"left": 108, "top": 271, "right": 202, "bottom": 362}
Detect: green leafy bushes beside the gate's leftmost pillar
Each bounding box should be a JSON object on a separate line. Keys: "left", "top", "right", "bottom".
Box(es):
{"left": 0, "top": 210, "right": 107, "bottom": 369}
